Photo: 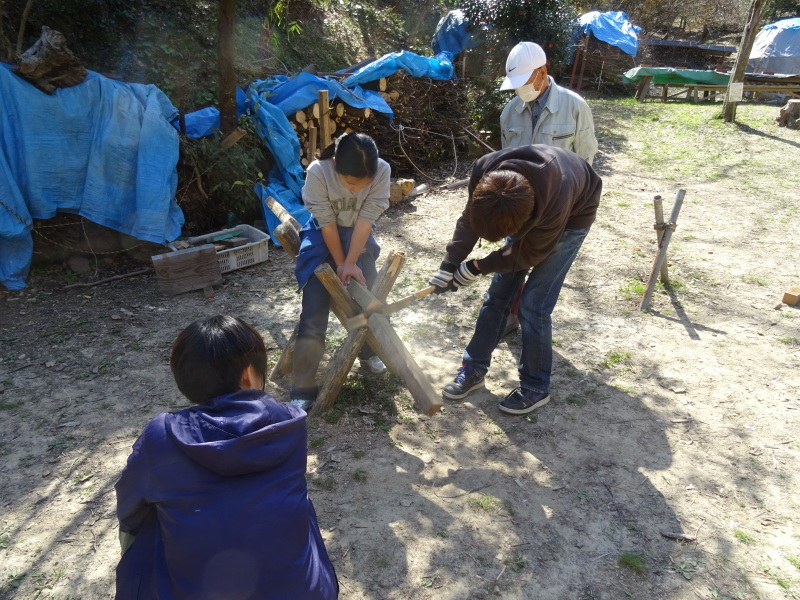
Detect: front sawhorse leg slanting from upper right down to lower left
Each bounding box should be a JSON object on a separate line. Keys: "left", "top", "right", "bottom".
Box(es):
{"left": 311, "top": 252, "right": 405, "bottom": 416}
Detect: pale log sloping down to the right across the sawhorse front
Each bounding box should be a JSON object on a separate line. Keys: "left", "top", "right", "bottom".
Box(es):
{"left": 348, "top": 282, "right": 442, "bottom": 415}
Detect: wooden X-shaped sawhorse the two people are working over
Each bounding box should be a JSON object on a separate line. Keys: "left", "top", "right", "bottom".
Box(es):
{"left": 265, "top": 198, "right": 442, "bottom": 416}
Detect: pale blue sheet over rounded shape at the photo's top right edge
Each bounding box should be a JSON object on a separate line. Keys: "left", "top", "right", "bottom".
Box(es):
{"left": 747, "top": 17, "right": 800, "bottom": 75}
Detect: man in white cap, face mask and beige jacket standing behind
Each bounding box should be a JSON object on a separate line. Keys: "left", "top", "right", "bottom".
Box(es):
{"left": 500, "top": 42, "right": 597, "bottom": 165}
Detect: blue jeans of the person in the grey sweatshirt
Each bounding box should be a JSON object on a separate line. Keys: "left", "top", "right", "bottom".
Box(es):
{"left": 290, "top": 246, "right": 378, "bottom": 401}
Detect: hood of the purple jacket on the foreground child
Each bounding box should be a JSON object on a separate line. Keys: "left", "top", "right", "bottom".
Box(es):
{"left": 164, "top": 390, "right": 306, "bottom": 477}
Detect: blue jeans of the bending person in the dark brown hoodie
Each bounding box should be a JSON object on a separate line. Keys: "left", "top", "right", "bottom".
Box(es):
{"left": 464, "top": 228, "right": 589, "bottom": 393}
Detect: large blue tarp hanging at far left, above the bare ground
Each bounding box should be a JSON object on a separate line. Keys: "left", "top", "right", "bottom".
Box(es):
{"left": 0, "top": 65, "right": 183, "bottom": 289}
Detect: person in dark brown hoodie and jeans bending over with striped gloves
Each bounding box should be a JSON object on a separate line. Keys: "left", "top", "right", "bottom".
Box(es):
{"left": 430, "top": 144, "right": 602, "bottom": 415}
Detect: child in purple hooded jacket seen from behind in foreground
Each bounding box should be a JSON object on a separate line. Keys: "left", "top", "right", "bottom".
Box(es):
{"left": 116, "top": 316, "right": 339, "bottom": 600}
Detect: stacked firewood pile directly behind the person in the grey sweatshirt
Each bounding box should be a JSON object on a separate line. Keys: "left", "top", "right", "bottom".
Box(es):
{"left": 289, "top": 73, "right": 471, "bottom": 173}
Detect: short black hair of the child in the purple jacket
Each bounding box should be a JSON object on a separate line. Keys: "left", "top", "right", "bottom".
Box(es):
{"left": 169, "top": 315, "right": 267, "bottom": 404}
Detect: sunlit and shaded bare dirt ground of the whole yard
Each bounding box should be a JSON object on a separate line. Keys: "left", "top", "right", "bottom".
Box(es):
{"left": 0, "top": 101, "right": 800, "bottom": 600}
